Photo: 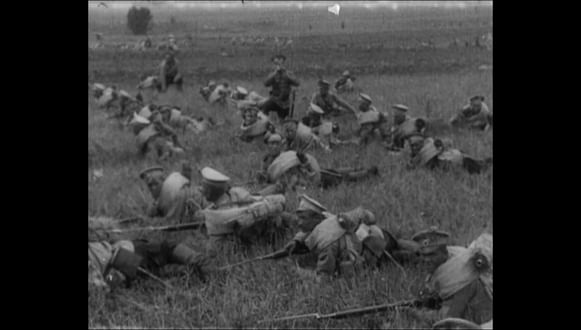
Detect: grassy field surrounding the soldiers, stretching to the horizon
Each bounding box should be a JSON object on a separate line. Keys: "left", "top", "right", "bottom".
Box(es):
{"left": 88, "top": 3, "right": 493, "bottom": 328}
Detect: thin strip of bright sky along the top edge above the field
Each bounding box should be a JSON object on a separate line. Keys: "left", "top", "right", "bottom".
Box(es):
{"left": 89, "top": 1, "right": 492, "bottom": 10}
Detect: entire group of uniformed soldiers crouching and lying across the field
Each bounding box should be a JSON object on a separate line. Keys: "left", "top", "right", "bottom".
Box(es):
{"left": 89, "top": 52, "right": 492, "bottom": 329}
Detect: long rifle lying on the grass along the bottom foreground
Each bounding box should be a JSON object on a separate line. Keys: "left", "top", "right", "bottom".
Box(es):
{"left": 258, "top": 299, "right": 424, "bottom": 323}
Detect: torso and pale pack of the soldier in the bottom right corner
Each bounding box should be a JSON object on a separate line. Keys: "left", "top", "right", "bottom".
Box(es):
{"left": 410, "top": 233, "right": 492, "bottom": 329}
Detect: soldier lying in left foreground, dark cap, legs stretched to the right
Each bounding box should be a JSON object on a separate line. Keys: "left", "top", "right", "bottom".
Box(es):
{"left": 89, "top": 236, "right": 215, "bottom": 289}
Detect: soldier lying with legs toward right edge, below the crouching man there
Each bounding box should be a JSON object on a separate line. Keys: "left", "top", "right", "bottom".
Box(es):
{"left": 407, "top": 134, "right": 492, "bottom": 174}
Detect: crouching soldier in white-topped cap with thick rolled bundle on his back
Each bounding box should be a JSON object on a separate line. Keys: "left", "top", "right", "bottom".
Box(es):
{"left": 200, "top": 167, "right": 289, "bottom": 249}
